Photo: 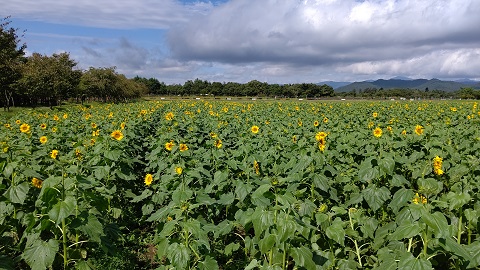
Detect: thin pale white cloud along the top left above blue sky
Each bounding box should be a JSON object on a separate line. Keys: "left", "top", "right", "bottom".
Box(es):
{"left": 0, "top": 0, "right": 213, "bottom": 29}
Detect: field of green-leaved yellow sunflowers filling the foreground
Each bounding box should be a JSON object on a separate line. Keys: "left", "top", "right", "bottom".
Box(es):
{"left": 0, "top": 100, "right": 480, "bottom": 269}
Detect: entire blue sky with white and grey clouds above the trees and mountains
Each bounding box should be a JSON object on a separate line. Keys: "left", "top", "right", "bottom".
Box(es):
{"left": 0, "top": 0, "right": 480, "bottom": 84}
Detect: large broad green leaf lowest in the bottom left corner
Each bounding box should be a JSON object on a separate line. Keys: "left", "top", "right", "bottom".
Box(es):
{"left": 22, "top": 239, "right": 59, "bottom": 270}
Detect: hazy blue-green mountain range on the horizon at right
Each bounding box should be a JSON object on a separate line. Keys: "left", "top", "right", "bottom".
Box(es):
{"left": 332, "top": 77, "right": 480, "bottom": 92}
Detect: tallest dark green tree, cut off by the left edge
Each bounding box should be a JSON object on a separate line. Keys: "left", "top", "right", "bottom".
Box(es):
{"left": 0, "top": 17, "right": 27, "bottom": 110}
